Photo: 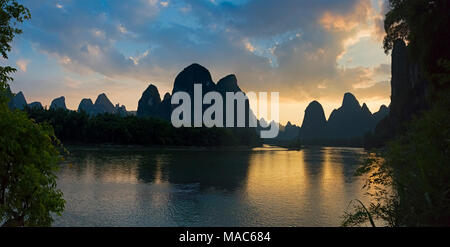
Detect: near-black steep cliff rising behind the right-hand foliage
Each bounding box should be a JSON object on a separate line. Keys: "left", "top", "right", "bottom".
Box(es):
{"left": 366, "top": 40, "right": 428, "bottom": 147}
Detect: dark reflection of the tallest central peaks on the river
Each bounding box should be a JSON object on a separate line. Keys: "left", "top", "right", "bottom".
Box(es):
{"left": 138, "top": 150, "right": 251, "bottom": 191}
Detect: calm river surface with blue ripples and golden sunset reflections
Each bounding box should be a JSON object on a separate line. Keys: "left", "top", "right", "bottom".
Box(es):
{"left": 55, "top": 147, "right": 365, "bottom": 226}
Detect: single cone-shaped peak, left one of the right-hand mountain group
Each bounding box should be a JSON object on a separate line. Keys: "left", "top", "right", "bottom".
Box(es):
{"left": 300, "top": 101, "right": 327, "bottom": 139}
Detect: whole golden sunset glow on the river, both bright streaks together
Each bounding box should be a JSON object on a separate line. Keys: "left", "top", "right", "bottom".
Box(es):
{"left": 245, "top": 148, "right": 363, "bottom": 225}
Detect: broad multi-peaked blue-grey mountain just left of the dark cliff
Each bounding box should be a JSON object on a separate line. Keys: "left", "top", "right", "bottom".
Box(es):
{"left": 327, "top": 93, "right": 374, "bottom": 138}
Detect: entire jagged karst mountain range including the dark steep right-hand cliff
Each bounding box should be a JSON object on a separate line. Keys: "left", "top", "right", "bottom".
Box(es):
{"left": 6, "top": 40, "right": 427, "bottom": 147}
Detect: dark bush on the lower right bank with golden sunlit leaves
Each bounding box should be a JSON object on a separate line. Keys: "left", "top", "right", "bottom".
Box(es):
{"left": 343, "top": 94, "right": 450, "bottom": 226}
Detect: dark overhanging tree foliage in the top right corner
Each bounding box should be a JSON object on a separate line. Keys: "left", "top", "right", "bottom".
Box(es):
{"left": 383, "top": 0, "right": 450, "bottom": 89}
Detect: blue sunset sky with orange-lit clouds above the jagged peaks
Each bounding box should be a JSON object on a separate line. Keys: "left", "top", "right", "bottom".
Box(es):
{"left": 2, "top": 0, "right": 391, "bottom": 124}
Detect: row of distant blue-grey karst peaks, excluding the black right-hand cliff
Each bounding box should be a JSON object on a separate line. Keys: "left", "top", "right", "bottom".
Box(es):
{"left": 4, "top": 64, "right": 389, "bottom": 144}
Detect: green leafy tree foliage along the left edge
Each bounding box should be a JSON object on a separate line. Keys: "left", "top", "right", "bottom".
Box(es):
{"left": 0, "top": 0, "right": 64, "bottom": 226}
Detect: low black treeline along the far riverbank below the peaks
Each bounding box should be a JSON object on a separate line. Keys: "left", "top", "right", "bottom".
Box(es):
{"left": 25, "top": 107, "right": 261, "bottom": 146}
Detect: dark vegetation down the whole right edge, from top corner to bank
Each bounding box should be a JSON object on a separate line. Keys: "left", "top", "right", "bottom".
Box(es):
{"left": 343, "top": 0, "right": 450, "bottom": 226}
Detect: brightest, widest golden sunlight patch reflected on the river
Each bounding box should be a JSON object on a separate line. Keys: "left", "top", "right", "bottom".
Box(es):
{"left": 245, "top": 151, "right": 311, "bottom": 224}
